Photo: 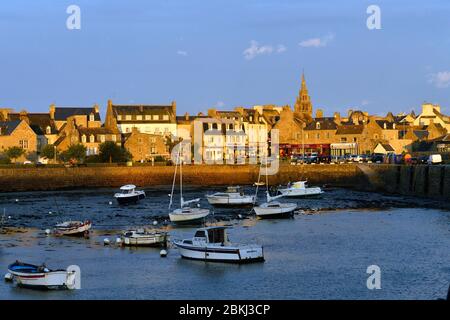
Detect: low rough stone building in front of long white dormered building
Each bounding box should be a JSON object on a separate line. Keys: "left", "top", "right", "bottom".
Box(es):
{"left": 123, "top": 128, "right": 170, "bottom": 162}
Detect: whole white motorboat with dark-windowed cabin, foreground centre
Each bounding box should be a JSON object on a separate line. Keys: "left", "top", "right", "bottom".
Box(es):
{"left": 174, "top": 227, "right": 264, "bottom": 263}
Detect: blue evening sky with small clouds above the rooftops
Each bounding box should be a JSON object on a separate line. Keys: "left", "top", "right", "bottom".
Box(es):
{"left": 0, "top": 0, "right": 450, "bottom": 115}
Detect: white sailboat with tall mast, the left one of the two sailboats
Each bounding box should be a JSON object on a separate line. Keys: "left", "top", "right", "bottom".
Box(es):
{"left": 169, "top": 148, "right": 210, "bottom": 223}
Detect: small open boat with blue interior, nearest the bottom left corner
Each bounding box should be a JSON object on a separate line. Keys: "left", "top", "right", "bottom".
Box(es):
{"left": 8, "top": 261, "right": 81, "bottom": 290}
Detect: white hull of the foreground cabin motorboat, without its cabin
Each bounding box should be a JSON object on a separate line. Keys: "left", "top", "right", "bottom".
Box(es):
{"left": 175, "top": 242, "right": 264, "bottom": 263}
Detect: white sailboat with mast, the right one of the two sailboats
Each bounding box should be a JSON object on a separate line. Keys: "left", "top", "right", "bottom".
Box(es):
{"left": 253, "top": 159, "right": 297, "bottom": 218}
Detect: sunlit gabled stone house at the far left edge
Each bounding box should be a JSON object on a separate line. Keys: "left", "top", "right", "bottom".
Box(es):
{"left": 0, "top": 120, "right": 40, "bottom": 162}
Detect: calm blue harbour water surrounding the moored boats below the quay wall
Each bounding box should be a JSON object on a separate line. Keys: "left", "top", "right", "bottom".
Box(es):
{"left": 0, "top": 187, "right": 450, "bottom": 299}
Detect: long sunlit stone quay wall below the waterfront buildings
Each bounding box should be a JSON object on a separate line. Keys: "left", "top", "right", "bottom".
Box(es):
{"left": 0, "top": 164, "right": 450, "bottom": 200}
